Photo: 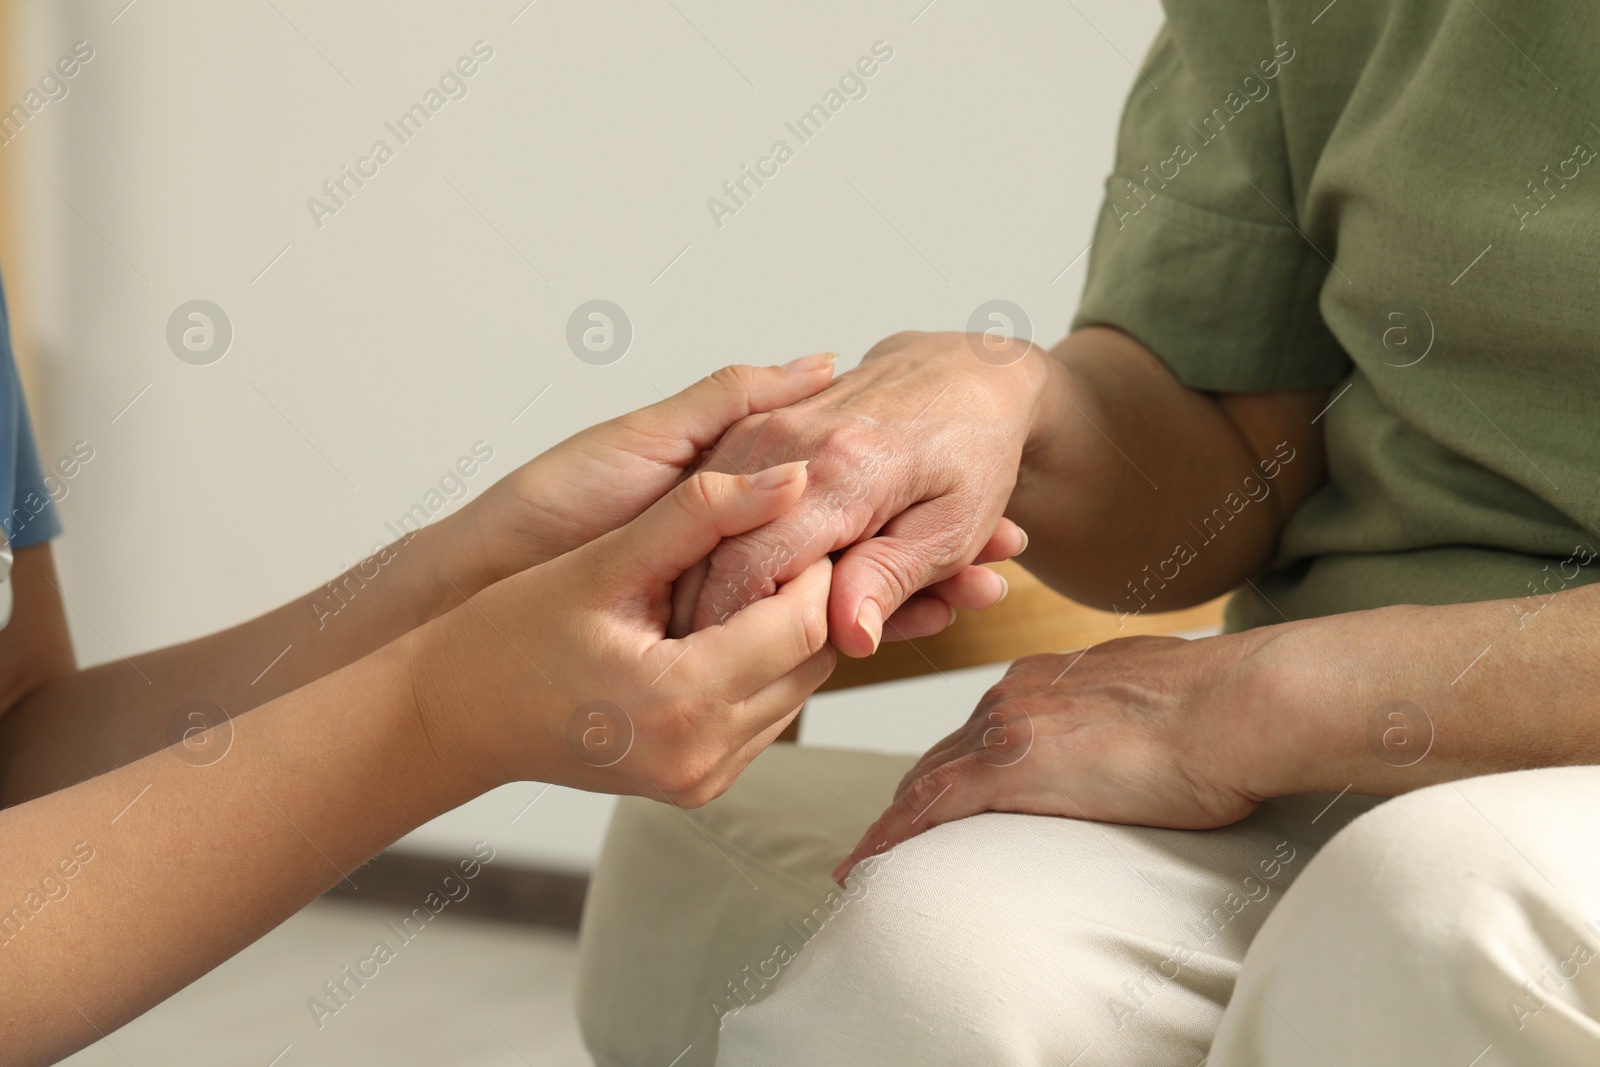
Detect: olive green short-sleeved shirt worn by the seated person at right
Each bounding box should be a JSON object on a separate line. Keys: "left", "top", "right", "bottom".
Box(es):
{"left": 1074, "top": 0, "right": 1600, "bottom": 630}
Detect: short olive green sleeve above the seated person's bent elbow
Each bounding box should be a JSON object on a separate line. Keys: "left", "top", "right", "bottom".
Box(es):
{"left": 1074, "top": 10, "right": 1352, "bottom": 392}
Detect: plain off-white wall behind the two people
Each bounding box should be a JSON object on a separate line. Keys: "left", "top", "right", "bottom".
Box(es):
{"left": 9, "top": 0, "right": 1160, "bottom": 870}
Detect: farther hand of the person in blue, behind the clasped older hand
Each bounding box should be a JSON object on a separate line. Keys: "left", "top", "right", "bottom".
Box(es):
{"left": 446, "top": 354, "right": 834, "bottom": 592}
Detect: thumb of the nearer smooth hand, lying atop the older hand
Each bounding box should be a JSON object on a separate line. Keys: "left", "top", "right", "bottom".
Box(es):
{"left": 595, "top": 459, "right": 808, "bottom": 582}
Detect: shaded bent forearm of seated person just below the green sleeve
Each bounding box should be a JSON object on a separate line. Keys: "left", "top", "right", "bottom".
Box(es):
{"left": 1006, "top": 328, "right": 1325, "bottom": 613}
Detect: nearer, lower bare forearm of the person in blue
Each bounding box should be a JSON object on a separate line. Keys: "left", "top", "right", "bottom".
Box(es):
{"left": 0, "top": 639, "right": 475, "bottom": 1067}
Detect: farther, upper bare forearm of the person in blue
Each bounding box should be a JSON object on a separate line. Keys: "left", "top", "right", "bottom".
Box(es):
{"left": 0, "top": 520, "right": 482, "bottom": 806}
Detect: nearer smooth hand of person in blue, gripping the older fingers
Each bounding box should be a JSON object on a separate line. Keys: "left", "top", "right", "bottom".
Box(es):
{"left": 403, "top": 462, "right": 834, "bottom": 806}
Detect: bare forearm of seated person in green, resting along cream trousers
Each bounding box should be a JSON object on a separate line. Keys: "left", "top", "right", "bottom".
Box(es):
{"left": 1248, "top": 585, "right": 1600, "bottom": 797}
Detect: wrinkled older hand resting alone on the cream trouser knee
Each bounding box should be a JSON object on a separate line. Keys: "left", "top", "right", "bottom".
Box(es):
{"left": 835, "top": 632, "right": 1269, "bottom": 881}
